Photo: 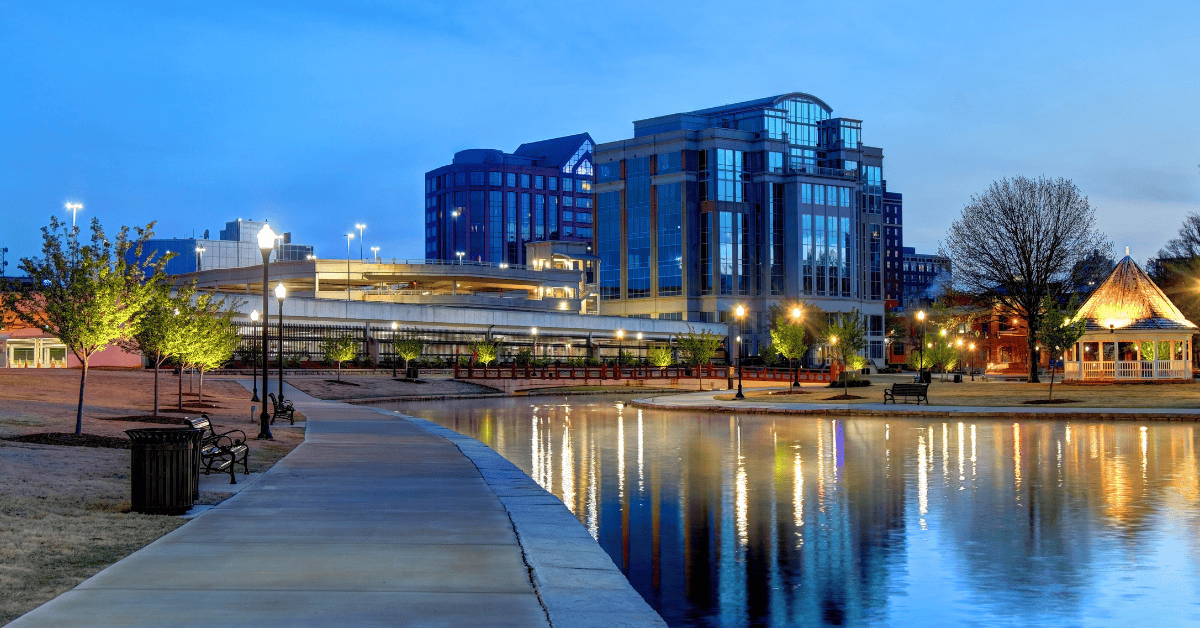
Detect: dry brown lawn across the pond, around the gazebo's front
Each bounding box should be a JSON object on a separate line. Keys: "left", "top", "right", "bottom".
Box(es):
{"left": 716, "top": 375, "right": 1200, "bottom": 408}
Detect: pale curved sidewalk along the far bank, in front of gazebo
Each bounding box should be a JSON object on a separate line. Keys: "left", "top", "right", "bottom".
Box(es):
{"left": 630, "top": 389, "right": 1200, "bottom": 420}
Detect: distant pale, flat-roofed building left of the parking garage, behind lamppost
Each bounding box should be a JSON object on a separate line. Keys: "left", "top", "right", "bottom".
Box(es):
{"left": 143, "top": 219, "right": 313, "bottom": 275}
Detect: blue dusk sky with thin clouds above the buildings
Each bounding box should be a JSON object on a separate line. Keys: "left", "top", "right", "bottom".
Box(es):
{"left": 0, "top": 0, "right": 1200, "bottom": 270}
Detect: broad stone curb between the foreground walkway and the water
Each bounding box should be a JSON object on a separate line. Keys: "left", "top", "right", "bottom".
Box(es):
{"left": 376, "top": 409, "right": 667, "bottom": 628}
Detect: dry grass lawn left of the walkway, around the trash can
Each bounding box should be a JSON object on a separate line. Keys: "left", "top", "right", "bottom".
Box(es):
{"left": 0, "top": 369, "right": 304, "bottom": 624}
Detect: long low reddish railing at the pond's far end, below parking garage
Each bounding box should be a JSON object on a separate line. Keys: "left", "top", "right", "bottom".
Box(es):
{"left": 454, "top": 364, "right": 840, "bottom": 382}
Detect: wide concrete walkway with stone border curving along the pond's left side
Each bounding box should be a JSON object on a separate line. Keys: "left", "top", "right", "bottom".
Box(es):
{"left": 10, "top": 390, "right": 665, "bottom": 628}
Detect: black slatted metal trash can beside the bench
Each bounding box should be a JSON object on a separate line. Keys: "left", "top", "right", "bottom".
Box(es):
{"left": 125, "top": 427, "right": 202, "bottom": 515}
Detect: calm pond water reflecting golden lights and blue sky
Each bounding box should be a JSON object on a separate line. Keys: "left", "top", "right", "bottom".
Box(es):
{"left": 392, "top": 396, "right": 1200, "bottom": 627}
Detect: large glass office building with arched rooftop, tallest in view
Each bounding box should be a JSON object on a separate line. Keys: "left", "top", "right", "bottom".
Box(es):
{"left": 595, "top": 94, "right": 884, "bottom": 365}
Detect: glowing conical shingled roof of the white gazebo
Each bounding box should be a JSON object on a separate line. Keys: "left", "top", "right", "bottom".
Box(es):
{"left": 1075, "top": 256, "right": 1196, "bottom": 331}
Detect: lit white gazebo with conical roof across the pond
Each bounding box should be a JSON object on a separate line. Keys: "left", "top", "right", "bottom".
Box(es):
{"left": 1063, "top": 255, "right": 1196, "bottom": 382}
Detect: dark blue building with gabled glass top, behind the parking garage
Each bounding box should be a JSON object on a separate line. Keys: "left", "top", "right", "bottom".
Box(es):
{"left": 425, "top": 133, "right": 595, "bottom": 264}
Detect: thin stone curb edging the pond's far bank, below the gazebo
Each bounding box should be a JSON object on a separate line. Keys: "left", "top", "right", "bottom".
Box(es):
{"left": 629, "top": 399, "right": 1200, "bottom": 421}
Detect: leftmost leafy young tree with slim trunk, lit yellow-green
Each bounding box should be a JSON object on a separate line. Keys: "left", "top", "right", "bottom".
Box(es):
{"left": 5, "top": 216, "right": 167, "bottom": 435}
